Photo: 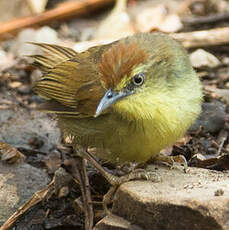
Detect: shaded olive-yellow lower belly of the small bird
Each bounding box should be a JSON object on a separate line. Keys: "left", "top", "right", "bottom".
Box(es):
{"left": 59, "top": 112, "right": 188, "bottom": 162}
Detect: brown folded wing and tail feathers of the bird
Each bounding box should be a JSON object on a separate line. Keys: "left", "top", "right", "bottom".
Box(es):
{"left": 32, "top": 43, "right": 105, "bottom": 118}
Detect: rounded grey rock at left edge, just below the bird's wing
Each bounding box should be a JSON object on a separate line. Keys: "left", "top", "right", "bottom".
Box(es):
{"left": 0, "top": 109, "right": 60, "bottom": 153}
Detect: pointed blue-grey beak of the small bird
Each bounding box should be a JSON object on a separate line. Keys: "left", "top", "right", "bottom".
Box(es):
{"left": 94, "top": 89, "right": 131, "bottom": 117}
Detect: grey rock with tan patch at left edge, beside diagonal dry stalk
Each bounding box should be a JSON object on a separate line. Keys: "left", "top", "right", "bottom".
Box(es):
{"left": 0, "top": 161, "right": 49, "bottom": 226}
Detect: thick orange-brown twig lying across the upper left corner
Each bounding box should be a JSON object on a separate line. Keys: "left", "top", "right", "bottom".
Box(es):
{"left": 0, "top": 0, "right": 114, "bottom": 40}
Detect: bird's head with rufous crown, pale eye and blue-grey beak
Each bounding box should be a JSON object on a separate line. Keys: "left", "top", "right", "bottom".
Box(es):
{"left": 95, "top": 34, "right": 189, "bottom": 117}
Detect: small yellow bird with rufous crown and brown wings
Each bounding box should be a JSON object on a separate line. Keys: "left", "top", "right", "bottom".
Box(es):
{"left": 33, "top": 33, "right": 202, "bottom": 182}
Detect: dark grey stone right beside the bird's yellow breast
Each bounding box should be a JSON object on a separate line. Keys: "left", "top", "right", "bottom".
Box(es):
{"left": 189, "top": 101, "right": 227, "bottom": 133}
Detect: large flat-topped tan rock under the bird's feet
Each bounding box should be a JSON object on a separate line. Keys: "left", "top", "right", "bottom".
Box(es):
{"left": 96, "top": 165, "right": 229, "bottom": 230}
